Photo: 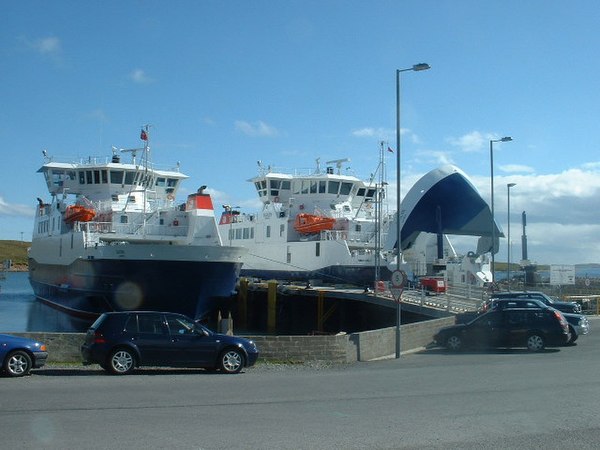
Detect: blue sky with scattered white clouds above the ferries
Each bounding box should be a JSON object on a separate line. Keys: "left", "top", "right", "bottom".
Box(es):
{"left": 0, "top": 0, "right": 600, "bottom": 264}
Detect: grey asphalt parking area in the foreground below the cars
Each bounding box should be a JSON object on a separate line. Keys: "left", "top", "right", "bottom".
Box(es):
{"left": 0, "top": 318, "right": 600, "bottom": 449}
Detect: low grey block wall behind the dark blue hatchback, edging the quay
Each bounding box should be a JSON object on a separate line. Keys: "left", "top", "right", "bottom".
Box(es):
{"left": 11, "top": 317, "right": 454, "bottom": 363}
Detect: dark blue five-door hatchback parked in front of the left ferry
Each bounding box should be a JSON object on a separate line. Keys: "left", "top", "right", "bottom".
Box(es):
{"left": 81, "top": 311, "right": 258, "bottom": 374}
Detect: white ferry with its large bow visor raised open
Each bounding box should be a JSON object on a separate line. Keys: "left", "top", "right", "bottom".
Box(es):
{"left": 219, "top": 157, "right": 501, "bottom": 286}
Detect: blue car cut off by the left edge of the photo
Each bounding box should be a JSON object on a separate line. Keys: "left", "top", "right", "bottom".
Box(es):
{"left": 0, "top": 334, "right": 48, "bottom": 377}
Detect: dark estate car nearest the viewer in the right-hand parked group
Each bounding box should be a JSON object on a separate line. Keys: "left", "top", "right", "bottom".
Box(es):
{"left": 433, "top": 307, "right": 571, "bottom": 351}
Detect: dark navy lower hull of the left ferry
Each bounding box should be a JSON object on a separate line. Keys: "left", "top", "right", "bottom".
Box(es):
{"left": 29, "top": 259, "right": 241, "bottom": 319}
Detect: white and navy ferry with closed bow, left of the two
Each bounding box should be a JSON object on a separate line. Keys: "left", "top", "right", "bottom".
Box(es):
{"left": 29, "top": 127, "right": 246, "bottom": 318}
